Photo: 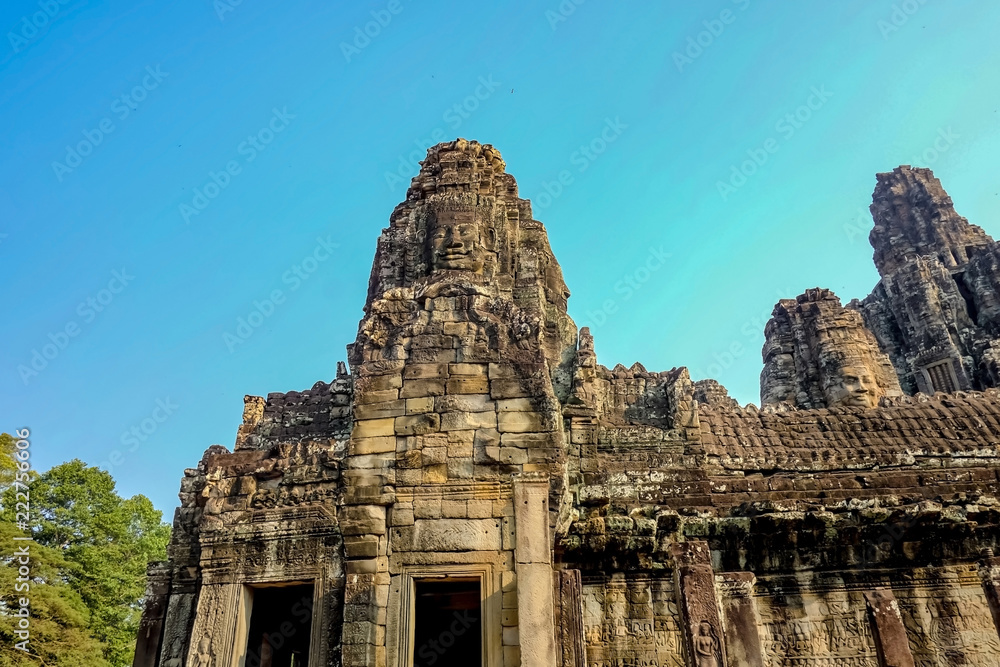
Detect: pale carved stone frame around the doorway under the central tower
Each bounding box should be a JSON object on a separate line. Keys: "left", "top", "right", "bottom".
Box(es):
{"left": 390, "top": 563, "right": 503, "bottom": 667}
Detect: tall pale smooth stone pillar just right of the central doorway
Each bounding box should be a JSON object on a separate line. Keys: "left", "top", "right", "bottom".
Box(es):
{"left": 514, "top": 477, "right": 557, "bottom": 667}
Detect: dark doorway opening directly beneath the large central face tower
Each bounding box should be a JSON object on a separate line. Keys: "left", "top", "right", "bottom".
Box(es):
{"left": 413, "top": 579, "right": 483, "bottom": 667}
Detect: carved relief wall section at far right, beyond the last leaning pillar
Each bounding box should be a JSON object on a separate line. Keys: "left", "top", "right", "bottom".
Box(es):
{"left": 894, "top": 582, "right": 1000, "bottom": 667}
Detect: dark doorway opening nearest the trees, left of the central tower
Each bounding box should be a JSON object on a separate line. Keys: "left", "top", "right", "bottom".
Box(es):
{"left": 243, "top": 584, "right": 313, "bottom": 667}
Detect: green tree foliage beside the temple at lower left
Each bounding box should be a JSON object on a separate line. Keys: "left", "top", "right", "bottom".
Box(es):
{"left": 0, "top": 444, "right": 170, "bottom": 667}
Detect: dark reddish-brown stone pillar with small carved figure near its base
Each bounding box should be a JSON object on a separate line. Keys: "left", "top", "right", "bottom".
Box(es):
{"left": 670, "top": 541, "right": 727, "bottom": 667}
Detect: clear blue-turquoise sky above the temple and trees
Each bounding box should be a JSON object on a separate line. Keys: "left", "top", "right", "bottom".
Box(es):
{"left": 0, "top": 0, "right": 1000, "bottom": 518}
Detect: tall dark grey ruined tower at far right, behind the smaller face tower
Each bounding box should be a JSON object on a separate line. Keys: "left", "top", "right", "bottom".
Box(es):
{"left": 850, "top": 166, "right": 1000, "bottom": 394}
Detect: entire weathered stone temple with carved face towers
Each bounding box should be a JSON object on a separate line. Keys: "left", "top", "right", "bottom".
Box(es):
{"left": 134, "top": 139, "right": 1000, "bottom": 667}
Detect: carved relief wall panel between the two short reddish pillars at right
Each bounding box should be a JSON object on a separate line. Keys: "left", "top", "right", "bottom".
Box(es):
{"left": 757, "top": 590, "right": 879, "bottom": 667}
